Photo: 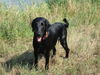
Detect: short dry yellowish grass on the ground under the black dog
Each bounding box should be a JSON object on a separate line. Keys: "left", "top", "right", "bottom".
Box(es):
{"left": 0, "top": 26, "right": 100, "bottom": 75}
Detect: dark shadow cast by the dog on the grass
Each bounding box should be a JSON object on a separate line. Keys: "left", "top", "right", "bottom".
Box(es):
{"left": 3, "top": 50, "right": 34, "bottom": 72}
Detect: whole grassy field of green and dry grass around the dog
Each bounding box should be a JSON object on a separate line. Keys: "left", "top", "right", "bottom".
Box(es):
{"left": 0, "top": 0, "right": 100, "bottom": 75}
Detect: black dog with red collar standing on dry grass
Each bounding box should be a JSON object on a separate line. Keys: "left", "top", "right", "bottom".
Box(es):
{"left": 31, "top": 17, "right": 69, "bottom": 69}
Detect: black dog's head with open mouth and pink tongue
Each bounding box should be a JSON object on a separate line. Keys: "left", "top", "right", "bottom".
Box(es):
{"left": 31, "top": 17, "right": 50, "bottom": 42}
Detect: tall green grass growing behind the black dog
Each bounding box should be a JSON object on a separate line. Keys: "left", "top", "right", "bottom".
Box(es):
{"left": 0, "top": 0, "right": 99, "bottom": 39}
